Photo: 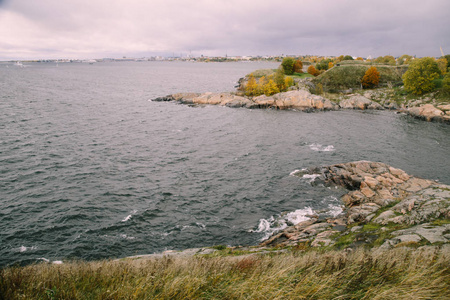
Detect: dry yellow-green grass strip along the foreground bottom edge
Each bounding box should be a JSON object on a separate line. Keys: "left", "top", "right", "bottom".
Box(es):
{"left": 0, "top": 248, "right": 450, "bottom": 299}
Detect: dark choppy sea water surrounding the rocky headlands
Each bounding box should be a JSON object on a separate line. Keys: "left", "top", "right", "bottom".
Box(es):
{"left": 0, "top": 62, "right": 450, "bottom": 266}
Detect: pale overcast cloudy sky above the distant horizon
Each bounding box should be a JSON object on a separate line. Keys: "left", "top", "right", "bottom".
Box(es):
{"left": 0, "top": 0, "right": 450, "bottom": 60}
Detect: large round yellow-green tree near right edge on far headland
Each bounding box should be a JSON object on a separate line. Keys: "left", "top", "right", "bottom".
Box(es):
{"left": 402, "top": 57, "right": 440, "bottom": 95}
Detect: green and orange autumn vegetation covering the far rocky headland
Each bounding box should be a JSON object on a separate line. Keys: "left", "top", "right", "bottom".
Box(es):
{"left": 245, "top": 54, "right": 450, "bottom": 104}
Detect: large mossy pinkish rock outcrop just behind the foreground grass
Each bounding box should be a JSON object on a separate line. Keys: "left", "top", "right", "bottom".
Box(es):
{"left": 261, "top": 161, "right": 450, "bottom": 248}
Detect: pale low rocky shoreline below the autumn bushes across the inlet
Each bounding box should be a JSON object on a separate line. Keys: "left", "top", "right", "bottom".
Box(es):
{"left": 152, "top": 89, "right": 450, "bottom": 124}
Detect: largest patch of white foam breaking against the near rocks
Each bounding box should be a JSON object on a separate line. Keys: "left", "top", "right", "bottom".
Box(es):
{"left": 250, "top": 207, "right": 314, "bottom": 241}
